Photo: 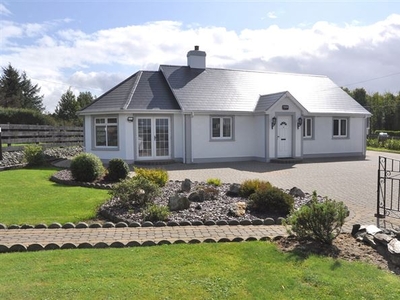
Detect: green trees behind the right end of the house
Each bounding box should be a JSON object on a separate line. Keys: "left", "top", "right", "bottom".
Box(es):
{"left": 343, "top": 87, "right": 400, "bottom": 133}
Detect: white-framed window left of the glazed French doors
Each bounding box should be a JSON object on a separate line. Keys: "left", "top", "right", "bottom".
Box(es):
{"left": 94, "top": 118, "right": 118, "bottom": 147}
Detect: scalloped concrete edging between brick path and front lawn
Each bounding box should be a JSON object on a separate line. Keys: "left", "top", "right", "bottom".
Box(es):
{"left": 0, "top": 235, "right": 283, "bottom": 253}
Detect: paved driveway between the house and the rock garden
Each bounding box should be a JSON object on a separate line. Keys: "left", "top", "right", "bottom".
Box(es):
{"left": 165, "top": 151, "right": 400, "bottom": 227}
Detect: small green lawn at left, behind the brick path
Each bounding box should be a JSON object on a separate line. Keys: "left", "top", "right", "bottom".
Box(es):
{"left": 0, "top": 167, "right": 108, "bottom": 225}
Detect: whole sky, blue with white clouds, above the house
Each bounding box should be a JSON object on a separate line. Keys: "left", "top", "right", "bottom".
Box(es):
{"left": 0, "top": 0, "right": 400, "bottom": 111}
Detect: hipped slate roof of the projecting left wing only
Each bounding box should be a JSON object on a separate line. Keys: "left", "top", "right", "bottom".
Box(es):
{"left": 82, "top": 71, "right": 180, "bottom": 113}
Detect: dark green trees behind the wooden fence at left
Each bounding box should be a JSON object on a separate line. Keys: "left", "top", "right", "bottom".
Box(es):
{"left": 0, "top": 64, "right": 96, "bottom": 126}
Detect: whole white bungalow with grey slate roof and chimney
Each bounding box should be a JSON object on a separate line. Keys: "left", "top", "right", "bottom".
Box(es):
{"left": 80, "top": 46, "right": 370, "bottom": 163}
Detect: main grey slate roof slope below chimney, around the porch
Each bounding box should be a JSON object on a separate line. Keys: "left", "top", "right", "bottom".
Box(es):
{"left": 160, "top": 65, "right": 370, "bottom": 115}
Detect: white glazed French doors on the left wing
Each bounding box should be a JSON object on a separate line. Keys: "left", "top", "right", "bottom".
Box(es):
{"left": 136, "top": 117, "right": 171, "bottom": 160}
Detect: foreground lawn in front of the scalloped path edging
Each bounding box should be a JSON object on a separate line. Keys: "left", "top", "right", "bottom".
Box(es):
{"left": 0, "top": 242, "right": 400, "bottom": 299}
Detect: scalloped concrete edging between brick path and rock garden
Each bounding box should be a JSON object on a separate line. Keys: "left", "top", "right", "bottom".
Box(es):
{"left": 0, "top": 217, "right": 285, "bottom": 230}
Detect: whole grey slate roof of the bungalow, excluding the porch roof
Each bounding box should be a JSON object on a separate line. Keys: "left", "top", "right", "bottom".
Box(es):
{"left": 81, "top": 65, "right": 370, "bottom": 116}
